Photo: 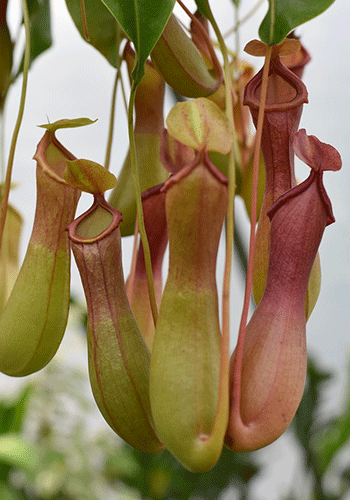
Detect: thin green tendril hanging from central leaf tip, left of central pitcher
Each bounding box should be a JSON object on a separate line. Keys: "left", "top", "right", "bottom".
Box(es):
{"left": 128, "top": 81, "right": 158, "bottom": 325}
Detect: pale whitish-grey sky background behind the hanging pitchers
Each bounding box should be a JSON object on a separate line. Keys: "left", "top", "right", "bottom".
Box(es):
{"left": 2, "top": 0, "right": 350, "bottom": 500}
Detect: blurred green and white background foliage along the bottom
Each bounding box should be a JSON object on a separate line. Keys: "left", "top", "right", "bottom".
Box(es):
{"left": 0, "top": 308, "right": 350, "bottom": 500}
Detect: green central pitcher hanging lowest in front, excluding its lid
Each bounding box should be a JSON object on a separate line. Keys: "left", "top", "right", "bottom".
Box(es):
{"left": 150, "top": 163, "right": 227, "bottom": 472}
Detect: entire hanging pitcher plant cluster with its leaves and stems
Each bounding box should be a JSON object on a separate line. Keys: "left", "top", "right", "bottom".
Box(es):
{"left": 0, "top": 0, "right": 341, "bottom": 472}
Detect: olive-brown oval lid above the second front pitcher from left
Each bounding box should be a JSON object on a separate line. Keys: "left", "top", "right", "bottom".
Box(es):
{"left": 64, "top": 160, "right": 117, "bottom": 195}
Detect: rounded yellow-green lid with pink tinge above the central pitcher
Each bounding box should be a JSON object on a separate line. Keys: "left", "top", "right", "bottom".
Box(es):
{"left": 166, "top": 97, "right": 233, "bottom": 154}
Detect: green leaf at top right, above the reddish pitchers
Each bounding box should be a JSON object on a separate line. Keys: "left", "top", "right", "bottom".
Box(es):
{"left": 259, "top": 0, "right": 334, "bottom": 45}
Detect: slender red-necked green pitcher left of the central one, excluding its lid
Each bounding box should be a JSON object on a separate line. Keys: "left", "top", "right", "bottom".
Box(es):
{"left": 68, "top": 198, "right": 163, "bottom": 452}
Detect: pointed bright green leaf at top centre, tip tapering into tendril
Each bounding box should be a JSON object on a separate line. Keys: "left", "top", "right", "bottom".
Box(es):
{"left": 101, "top": 0, "right": 175, "bottom": 85}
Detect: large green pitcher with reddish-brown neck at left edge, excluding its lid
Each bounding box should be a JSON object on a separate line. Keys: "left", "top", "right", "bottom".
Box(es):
{"left": 0, "top": 131, "right": 80, "bottom": 376}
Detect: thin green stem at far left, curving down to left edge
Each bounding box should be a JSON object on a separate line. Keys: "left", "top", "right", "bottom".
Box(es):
{"left": 0, "top": 0, "right": 30, "bottom": 253}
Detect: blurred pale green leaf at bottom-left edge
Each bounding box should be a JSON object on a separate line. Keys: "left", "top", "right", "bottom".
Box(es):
{"left": 0, "top": 434, "right": 39, "bottom": 470}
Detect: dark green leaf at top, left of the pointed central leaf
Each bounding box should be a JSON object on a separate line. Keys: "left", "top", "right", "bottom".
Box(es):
{"left": 66, "top": 0, "right": 121, "bottom": 68}
